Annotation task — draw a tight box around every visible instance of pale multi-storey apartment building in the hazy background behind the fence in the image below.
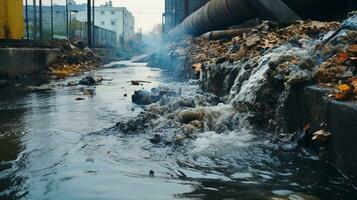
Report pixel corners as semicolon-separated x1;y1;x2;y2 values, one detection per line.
73;1;135;42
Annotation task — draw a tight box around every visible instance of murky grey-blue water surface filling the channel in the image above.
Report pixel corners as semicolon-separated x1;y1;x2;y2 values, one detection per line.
0;62;357;200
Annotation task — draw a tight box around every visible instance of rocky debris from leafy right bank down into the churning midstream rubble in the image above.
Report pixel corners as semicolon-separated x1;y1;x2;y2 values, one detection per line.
119;14;357;153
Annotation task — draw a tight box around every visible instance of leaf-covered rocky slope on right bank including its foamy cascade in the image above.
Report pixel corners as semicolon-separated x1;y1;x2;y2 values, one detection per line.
161;16;357;129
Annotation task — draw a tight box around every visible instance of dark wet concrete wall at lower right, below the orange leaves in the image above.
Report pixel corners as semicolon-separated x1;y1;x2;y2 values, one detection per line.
282;86;357;183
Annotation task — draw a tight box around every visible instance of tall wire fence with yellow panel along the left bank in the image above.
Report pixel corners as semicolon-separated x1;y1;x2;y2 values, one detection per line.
0;0;116;47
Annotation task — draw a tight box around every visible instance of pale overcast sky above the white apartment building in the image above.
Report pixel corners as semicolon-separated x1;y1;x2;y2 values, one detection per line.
48;0;165;32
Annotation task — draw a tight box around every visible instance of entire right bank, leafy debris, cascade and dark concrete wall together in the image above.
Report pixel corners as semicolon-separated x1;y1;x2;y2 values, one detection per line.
149;15;357;183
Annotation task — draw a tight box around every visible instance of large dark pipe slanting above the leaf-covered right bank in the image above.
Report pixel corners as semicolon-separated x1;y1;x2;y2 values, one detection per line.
169;0;348;38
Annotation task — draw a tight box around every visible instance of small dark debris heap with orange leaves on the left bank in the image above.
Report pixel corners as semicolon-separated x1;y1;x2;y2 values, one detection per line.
48;40;104;78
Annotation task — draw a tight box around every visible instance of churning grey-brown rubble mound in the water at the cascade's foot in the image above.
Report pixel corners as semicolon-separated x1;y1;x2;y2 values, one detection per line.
116;85;236;145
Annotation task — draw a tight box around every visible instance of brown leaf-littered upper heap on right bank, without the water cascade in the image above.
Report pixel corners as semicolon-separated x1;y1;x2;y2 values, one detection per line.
170;15;357;100
